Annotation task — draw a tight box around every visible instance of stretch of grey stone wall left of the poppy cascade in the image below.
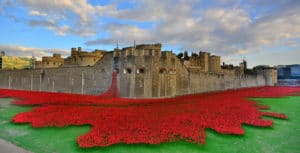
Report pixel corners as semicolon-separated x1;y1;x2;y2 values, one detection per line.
0;54;112;94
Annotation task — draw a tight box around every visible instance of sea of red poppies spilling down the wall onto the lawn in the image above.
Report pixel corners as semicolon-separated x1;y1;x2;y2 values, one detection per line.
0;74;300;148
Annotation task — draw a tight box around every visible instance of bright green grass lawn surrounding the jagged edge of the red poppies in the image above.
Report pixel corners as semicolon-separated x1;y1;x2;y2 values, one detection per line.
0;96;300;153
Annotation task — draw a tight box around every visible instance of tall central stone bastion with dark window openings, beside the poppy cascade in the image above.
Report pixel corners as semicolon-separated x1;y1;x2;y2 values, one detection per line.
119;52;187;97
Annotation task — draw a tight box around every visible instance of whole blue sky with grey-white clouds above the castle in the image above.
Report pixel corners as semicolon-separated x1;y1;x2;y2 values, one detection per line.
0;0;300;66
